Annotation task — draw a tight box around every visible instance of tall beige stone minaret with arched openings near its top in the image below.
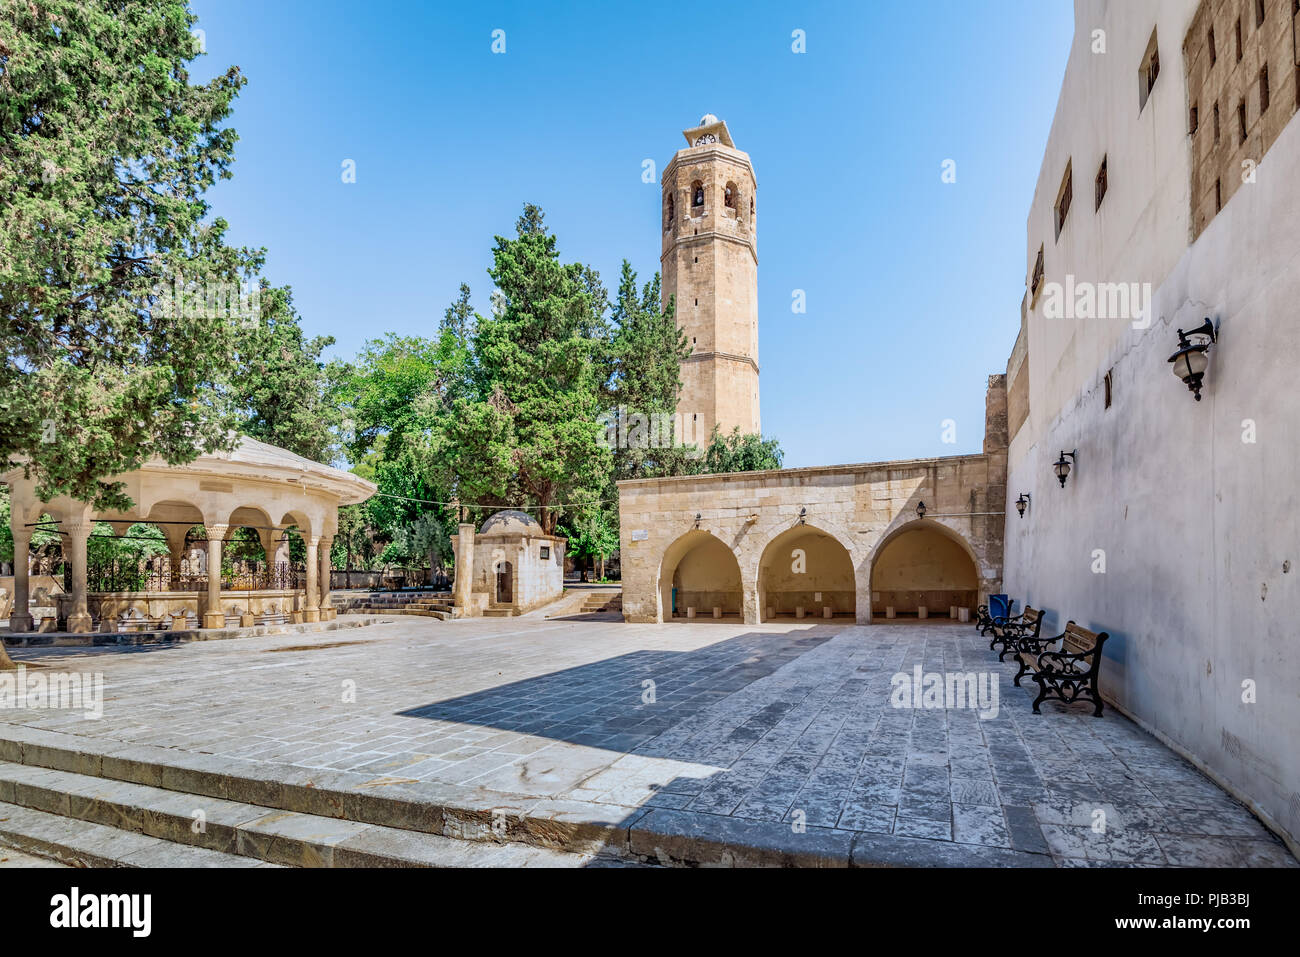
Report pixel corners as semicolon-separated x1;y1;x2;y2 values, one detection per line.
659;114;759;443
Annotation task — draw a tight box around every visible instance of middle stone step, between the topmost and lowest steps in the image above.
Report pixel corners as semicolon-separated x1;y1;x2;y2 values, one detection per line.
0;762;590;867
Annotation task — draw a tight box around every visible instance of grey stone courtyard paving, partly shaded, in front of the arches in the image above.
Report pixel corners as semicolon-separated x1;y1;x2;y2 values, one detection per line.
0;618;1296;866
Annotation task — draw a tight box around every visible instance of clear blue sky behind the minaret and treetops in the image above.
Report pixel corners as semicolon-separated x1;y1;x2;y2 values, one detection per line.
192;0;1074;467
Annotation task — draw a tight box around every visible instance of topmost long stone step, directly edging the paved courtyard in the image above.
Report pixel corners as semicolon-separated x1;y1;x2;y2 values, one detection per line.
0;724;1052;867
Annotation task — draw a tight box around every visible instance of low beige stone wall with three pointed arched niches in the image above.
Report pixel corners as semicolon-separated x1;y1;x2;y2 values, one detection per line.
619;376;1006;623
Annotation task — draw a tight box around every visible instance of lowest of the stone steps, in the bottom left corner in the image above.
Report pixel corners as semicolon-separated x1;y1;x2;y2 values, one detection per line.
0;802;277;867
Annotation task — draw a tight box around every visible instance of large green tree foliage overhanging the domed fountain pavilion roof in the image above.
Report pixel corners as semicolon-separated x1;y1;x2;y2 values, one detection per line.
0;0;261;507
